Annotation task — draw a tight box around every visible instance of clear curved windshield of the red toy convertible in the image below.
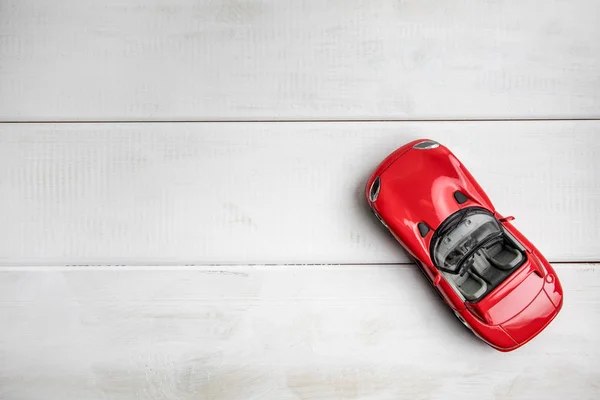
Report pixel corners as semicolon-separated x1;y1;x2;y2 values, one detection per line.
433;209;502;273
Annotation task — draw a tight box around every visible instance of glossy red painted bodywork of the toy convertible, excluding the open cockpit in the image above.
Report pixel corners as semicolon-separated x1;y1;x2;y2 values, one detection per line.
365;139;563;351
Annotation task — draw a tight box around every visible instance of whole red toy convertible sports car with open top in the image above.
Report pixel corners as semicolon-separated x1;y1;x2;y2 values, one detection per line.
365;139;563;351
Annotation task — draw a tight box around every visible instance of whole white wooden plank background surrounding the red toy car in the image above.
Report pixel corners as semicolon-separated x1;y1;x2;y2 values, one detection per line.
0;0;600;400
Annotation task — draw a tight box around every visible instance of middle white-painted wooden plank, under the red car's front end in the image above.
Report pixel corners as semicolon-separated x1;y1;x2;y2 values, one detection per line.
0;121;600;265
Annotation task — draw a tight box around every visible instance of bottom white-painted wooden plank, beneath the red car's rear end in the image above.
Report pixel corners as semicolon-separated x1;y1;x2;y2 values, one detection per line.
0;265;600;400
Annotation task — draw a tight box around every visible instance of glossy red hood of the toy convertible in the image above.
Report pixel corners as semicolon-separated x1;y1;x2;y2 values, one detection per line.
377;146;493;229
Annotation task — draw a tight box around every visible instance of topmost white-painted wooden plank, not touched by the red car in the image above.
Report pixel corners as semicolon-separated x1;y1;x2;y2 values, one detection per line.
0;0;600;121
